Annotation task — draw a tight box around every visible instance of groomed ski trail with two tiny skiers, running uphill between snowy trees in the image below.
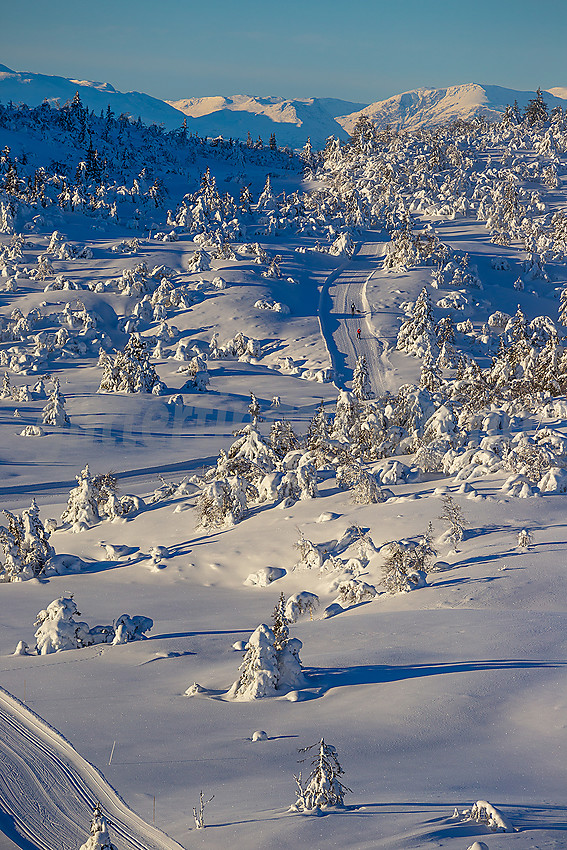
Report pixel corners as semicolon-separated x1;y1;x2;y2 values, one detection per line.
319;237;391;395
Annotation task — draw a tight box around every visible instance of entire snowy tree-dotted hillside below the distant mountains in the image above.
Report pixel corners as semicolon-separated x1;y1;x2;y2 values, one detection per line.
0;69;567;850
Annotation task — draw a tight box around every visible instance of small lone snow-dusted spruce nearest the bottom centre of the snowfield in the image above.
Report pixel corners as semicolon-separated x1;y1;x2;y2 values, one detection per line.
291;738;352;812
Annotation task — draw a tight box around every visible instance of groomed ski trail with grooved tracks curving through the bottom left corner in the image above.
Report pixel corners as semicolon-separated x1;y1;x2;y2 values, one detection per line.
0;688;182;850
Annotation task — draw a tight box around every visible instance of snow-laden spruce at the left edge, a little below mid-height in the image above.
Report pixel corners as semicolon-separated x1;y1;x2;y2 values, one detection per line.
0;499;55;581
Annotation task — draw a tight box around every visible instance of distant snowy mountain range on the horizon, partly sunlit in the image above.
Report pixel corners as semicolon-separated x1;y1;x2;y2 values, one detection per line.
0;65;567;148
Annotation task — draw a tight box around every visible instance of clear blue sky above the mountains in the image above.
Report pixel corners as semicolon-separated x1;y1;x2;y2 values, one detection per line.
0;0;567;102
